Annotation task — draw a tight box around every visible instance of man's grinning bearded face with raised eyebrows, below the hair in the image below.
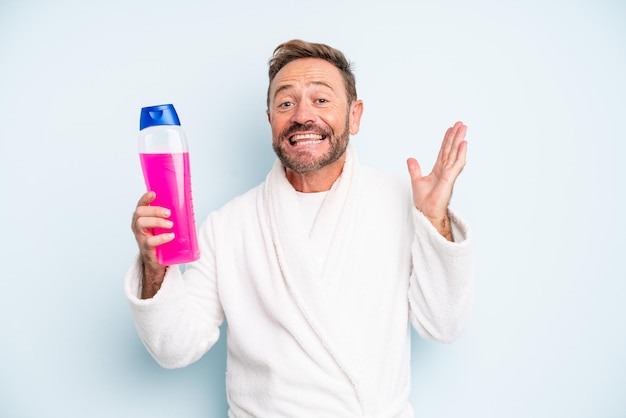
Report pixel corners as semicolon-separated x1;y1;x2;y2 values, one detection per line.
267;58;362;174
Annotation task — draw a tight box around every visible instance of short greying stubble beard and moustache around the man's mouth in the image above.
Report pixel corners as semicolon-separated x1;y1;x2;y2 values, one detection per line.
272;118;350;174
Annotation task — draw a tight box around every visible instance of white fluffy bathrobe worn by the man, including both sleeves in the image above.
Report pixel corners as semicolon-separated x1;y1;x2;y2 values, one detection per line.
125;147;473;418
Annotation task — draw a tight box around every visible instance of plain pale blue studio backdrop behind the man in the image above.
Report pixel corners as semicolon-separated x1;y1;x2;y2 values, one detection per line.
0;0;626;418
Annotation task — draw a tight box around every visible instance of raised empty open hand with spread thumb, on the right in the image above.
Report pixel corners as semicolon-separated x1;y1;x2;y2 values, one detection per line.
407;122;467;241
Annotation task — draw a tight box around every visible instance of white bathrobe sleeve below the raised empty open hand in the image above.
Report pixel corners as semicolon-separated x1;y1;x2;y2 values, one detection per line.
409;208;474;343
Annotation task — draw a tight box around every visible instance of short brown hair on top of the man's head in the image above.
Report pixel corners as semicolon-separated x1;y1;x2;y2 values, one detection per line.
267;39;357;108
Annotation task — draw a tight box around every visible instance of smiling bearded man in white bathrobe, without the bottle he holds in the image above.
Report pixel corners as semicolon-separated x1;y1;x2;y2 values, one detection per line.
126;40;473;417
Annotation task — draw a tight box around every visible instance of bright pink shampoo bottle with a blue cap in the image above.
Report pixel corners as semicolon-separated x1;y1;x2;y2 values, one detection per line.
139;104;200;266
